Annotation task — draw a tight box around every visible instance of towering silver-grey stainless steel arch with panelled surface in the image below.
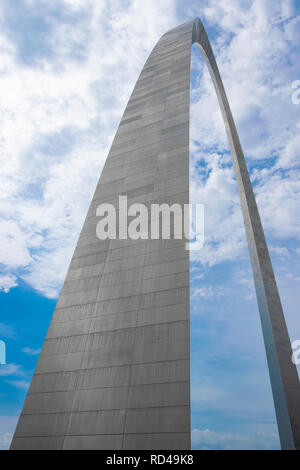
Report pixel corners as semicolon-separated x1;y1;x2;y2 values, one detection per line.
11;19;300;450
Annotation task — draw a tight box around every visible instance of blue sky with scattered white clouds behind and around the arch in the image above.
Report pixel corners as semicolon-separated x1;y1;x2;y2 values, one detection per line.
0;0;300;449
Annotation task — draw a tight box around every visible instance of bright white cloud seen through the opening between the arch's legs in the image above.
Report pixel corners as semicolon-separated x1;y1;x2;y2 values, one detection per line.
191;153;246;265
